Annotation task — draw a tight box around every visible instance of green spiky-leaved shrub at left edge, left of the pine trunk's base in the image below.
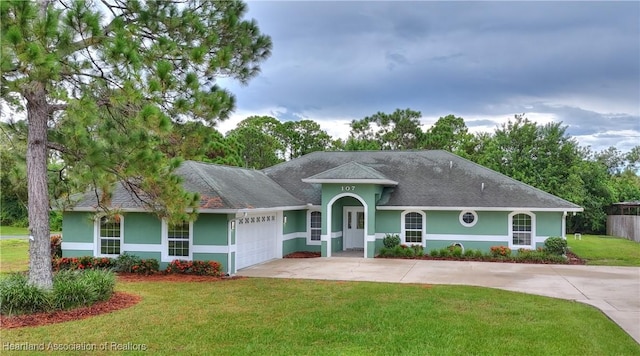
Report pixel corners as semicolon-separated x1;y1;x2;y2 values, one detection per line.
0;273;51;315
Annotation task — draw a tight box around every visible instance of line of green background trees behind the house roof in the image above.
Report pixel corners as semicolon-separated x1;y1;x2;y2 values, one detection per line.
0;109;640;233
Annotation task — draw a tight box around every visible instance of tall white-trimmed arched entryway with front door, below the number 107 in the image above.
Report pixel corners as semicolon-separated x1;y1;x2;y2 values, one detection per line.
326;193;369;257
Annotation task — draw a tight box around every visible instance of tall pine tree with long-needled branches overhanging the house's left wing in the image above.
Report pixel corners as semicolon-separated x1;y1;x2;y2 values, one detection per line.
0;0;271;288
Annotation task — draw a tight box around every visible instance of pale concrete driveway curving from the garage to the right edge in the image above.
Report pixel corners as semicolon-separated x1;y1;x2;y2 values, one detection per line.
237;257;640;343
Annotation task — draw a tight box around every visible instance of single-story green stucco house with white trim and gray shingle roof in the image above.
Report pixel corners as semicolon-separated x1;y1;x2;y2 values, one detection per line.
62;151;583;274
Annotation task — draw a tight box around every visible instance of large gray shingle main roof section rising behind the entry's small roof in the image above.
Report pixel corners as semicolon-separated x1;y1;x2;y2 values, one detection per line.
263;151;581;211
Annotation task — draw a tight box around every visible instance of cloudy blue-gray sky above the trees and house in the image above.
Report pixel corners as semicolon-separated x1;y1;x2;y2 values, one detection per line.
218;1;640;151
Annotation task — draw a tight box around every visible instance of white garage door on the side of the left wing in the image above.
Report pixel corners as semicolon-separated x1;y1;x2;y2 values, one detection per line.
236;213;278;269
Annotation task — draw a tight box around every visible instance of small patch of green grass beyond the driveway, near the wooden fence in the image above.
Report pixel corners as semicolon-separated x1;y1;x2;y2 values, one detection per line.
567;235;640;266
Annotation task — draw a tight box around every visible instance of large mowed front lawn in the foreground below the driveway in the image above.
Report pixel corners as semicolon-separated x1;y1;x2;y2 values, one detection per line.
2;278;640;355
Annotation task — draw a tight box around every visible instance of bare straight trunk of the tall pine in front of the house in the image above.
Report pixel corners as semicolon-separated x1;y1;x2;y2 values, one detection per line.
24;82;53;289
